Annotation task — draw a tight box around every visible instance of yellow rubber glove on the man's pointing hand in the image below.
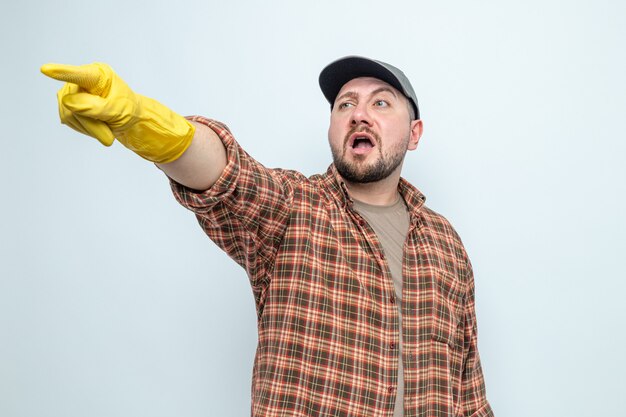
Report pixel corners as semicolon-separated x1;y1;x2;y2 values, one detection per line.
41;63;195;163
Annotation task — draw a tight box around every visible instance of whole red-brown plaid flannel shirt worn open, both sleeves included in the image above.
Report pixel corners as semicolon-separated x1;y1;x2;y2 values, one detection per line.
172;116;493;417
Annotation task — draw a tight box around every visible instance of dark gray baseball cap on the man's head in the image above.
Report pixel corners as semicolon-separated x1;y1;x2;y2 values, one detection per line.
319;56;420;119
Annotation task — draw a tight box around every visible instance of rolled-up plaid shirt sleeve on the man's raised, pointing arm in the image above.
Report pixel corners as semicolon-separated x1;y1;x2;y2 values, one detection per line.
170;116;293;295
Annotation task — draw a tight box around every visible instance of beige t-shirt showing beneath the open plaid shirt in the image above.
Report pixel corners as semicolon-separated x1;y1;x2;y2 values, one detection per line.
354;194;409;417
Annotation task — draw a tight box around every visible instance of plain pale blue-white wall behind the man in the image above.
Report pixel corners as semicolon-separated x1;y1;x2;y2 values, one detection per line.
0;0;626;417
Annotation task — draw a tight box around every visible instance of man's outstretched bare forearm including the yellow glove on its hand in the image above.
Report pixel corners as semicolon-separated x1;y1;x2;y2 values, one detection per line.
41;63;226;190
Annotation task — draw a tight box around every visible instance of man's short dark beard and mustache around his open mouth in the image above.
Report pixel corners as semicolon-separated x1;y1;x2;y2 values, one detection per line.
330;127;409;184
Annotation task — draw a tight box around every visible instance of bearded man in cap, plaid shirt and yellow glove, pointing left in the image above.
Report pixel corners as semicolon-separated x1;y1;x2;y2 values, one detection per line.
42;57;493;417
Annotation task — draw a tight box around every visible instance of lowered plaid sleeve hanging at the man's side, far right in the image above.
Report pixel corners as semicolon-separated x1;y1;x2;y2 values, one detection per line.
461;265;494;417
